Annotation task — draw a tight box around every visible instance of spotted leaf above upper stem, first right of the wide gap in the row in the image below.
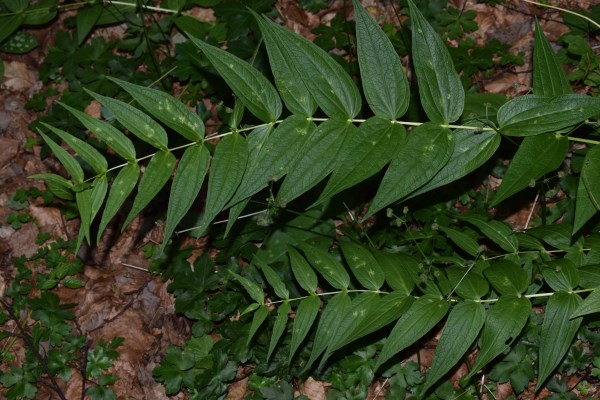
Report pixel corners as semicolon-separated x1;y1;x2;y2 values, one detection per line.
189;35;281;122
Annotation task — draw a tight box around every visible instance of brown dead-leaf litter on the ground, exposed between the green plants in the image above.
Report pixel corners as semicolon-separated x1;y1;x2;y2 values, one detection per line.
0;0;600;399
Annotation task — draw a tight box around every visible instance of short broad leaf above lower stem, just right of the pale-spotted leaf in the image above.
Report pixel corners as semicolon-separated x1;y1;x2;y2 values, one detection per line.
375;251;419;296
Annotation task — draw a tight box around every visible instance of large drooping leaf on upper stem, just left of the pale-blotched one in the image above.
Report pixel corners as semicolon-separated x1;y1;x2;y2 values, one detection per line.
315;117;406;204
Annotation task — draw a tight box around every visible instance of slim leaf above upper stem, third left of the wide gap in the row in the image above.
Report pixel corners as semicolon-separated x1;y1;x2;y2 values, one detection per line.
58;101;135;162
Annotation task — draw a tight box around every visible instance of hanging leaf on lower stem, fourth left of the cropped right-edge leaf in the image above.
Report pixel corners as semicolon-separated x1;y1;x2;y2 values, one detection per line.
374;295;449;370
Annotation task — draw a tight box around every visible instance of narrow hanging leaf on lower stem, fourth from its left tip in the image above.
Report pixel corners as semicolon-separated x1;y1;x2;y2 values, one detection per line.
304;292;350;370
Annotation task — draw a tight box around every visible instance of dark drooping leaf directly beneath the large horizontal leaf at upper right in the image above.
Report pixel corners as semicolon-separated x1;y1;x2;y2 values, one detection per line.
490;134;569;207
